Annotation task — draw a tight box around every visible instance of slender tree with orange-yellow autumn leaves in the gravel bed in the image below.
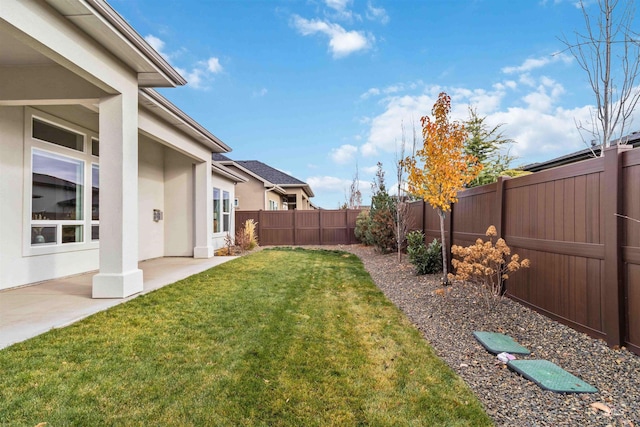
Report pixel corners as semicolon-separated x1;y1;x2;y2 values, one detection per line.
401;92;482;283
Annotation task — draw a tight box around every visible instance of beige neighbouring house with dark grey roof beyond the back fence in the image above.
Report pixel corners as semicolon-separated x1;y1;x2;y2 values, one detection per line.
213;153;316;211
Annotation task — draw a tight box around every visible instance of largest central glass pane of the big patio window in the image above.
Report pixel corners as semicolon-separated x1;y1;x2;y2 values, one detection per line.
31;150;84;220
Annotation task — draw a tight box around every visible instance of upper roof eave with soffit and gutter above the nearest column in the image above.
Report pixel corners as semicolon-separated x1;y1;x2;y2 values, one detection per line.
46;0;187;87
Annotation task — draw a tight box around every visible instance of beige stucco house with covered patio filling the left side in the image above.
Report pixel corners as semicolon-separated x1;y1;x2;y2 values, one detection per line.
0;0;235;298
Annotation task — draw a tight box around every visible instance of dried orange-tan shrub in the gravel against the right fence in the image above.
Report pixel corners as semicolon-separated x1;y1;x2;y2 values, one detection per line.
449;225;530;309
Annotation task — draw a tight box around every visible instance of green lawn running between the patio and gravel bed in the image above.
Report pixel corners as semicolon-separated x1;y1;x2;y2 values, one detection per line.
0;249;491;426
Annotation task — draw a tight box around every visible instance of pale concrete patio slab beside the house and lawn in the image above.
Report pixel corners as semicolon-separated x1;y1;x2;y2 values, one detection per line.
0;256;236;349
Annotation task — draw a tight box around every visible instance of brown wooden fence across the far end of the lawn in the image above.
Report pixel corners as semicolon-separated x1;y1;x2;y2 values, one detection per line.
236;209;360;246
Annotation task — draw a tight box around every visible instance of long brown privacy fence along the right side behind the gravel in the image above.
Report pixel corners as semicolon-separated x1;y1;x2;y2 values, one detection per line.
410;146;640;354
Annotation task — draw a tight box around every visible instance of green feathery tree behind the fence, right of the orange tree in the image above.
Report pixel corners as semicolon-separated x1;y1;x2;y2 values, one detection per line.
464;107;514;187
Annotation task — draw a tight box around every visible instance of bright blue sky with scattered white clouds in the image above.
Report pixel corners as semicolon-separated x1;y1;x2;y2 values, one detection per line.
110;0;640;209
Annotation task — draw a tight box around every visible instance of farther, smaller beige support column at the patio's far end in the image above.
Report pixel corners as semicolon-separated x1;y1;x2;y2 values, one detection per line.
193;159;215;258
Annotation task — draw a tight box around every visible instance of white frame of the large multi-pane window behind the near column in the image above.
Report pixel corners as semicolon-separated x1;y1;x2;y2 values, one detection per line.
22;107;99;256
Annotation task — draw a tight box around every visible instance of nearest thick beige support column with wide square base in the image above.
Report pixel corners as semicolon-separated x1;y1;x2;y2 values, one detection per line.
93;92;143;298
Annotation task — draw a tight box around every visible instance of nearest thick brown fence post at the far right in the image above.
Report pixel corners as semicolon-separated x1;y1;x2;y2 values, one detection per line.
601;145;632;347
